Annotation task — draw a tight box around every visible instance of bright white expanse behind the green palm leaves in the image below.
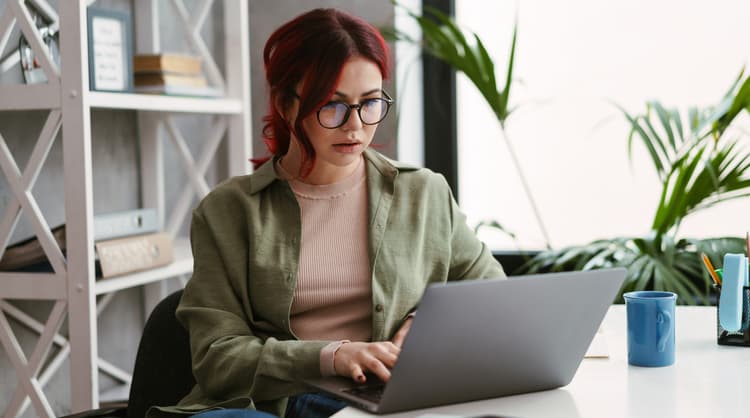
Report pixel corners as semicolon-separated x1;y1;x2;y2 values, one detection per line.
456;0;750;249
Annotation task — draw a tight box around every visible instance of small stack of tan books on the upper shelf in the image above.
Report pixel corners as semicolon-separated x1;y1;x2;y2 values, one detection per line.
133;54;219;97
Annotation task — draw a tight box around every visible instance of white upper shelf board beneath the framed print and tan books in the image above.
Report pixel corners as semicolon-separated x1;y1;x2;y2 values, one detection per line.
88;91;243;114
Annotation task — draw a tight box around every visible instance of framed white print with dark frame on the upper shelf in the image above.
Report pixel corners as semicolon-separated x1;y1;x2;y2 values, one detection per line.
87;7;133;92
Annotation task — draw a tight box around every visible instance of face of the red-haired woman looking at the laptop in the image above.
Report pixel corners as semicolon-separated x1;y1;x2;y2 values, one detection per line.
294;57;383;184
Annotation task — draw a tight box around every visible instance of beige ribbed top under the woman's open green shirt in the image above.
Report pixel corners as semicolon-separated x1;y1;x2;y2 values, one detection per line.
276;159;372;341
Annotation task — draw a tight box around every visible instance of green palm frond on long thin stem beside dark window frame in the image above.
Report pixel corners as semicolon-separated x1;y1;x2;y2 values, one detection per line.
383;1;550;248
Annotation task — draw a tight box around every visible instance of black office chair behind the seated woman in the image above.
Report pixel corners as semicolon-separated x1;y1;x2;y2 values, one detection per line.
66;290;195;418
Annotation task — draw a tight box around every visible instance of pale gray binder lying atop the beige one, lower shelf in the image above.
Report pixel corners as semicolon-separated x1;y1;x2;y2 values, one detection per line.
94;208;159;241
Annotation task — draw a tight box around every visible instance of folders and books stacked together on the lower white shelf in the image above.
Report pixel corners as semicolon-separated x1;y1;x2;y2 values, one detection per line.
0;208;174;278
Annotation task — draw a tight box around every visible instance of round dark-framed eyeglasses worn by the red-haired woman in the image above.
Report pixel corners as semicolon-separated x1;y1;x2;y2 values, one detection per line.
295;91;393;129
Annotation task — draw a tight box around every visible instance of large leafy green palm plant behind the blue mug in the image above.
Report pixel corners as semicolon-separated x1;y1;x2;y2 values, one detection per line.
526;72;750;304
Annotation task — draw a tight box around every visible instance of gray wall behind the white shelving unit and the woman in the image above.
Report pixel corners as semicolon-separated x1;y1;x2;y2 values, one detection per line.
0;0;396;417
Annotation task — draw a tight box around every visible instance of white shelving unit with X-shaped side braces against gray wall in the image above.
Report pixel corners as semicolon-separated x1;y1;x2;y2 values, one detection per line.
0;0;251;418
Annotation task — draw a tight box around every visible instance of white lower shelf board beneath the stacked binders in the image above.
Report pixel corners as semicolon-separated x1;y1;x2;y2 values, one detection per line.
94;238;193;295
